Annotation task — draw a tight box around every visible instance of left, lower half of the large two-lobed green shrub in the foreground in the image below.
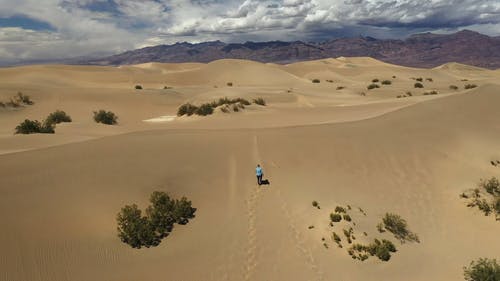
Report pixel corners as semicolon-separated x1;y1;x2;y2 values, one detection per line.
116;204;160;249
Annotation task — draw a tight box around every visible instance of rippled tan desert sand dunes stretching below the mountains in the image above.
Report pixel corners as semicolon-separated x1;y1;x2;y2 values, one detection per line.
0;58;500;281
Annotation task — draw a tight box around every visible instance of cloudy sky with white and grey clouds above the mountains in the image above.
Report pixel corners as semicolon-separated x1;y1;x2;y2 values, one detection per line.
0;0;500;64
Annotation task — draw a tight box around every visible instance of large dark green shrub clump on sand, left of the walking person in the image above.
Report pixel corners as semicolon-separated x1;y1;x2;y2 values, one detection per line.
116;191;196;248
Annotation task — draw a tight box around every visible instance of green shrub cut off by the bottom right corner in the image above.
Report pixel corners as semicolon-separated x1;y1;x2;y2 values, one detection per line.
464;258;500;281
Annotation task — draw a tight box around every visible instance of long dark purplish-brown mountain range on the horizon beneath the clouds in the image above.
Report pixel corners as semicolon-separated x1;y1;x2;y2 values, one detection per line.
78;30;500;69
